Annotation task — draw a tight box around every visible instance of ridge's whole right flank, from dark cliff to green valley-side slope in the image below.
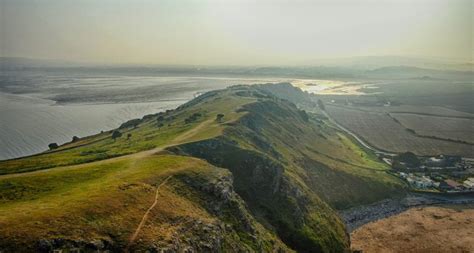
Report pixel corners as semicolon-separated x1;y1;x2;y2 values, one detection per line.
171;86;402;252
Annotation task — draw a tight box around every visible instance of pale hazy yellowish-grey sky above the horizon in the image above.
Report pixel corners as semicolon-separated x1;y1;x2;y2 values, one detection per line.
0;0;473;65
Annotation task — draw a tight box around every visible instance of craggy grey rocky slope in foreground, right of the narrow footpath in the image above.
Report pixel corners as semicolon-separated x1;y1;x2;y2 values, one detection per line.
125;171;292;252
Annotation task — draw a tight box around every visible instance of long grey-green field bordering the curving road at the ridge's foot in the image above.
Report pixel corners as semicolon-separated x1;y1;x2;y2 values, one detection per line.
326;105;474;157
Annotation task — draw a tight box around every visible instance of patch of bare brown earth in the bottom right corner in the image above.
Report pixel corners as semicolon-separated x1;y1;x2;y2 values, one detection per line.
351;205;474;253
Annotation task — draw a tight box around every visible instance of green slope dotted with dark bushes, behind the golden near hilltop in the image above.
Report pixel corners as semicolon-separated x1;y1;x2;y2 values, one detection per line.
0;94;253;175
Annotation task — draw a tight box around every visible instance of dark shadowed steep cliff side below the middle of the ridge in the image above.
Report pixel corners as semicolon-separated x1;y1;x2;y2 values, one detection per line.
169;137;348;252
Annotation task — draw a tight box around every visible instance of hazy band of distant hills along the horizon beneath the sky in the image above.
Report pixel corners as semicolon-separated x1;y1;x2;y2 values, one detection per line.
0;57;474;80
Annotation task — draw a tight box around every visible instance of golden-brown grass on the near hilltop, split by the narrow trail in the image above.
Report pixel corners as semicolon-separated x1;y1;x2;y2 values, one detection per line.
0;155;220;250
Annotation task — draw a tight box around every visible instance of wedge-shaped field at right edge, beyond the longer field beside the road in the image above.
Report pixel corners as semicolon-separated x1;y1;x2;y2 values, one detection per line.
390;113;474;144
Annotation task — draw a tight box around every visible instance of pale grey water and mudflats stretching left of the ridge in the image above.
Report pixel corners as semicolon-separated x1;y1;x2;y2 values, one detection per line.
0;70;322;160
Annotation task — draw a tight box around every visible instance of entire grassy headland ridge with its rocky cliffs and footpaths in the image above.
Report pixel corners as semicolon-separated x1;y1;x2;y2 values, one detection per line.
0;84;404;252
